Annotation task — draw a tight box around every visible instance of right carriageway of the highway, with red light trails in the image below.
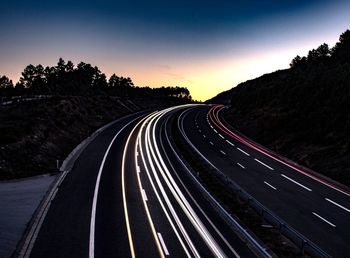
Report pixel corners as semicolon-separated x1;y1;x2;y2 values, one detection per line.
181;106;350;257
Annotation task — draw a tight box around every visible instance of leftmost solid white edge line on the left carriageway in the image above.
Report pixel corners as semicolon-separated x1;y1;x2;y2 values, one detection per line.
89;116;141;258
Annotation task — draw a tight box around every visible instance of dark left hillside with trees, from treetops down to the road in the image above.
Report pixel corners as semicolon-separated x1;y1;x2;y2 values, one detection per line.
0;59;191;179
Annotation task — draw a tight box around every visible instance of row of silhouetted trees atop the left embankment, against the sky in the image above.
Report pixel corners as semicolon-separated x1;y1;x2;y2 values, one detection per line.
0;58;191;100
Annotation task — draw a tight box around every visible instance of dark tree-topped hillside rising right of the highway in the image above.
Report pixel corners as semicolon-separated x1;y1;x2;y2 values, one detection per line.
211;30;350;186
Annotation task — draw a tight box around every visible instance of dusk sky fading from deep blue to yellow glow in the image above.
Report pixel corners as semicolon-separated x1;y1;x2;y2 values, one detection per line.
0;0;350;100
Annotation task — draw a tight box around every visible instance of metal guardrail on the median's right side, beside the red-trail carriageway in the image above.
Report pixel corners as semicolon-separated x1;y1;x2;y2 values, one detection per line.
181;107;331;258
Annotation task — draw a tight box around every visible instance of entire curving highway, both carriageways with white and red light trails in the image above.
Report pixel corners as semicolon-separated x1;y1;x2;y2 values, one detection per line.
25;105;350;258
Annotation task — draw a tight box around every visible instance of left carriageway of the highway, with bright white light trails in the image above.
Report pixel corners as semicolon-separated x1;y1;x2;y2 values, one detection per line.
26;106;258;258
